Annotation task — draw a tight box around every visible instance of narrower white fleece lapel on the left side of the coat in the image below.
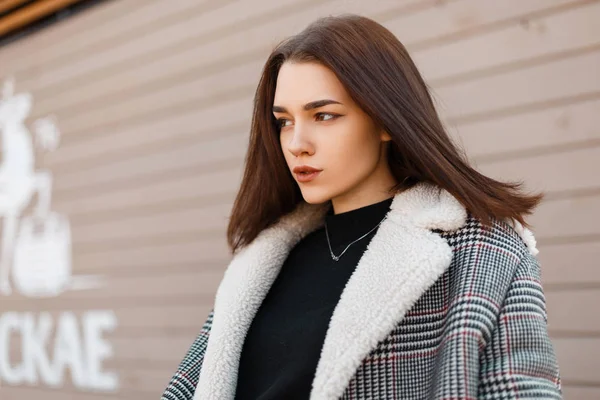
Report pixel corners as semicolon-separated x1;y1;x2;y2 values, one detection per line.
194;203;327;400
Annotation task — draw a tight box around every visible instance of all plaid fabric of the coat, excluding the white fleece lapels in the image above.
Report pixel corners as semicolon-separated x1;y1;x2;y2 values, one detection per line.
162;218;562;400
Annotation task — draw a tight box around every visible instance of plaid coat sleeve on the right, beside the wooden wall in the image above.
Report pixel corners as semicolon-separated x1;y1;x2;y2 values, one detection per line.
478;254;562;399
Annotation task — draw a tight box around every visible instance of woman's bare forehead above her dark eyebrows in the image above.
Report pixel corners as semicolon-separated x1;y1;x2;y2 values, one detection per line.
274;62;348;107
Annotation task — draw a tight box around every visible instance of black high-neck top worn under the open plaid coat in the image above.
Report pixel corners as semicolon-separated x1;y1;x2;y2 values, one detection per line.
235;197;393;400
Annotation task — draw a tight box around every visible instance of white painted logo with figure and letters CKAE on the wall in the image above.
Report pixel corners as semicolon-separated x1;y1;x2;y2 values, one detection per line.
0;80;118;391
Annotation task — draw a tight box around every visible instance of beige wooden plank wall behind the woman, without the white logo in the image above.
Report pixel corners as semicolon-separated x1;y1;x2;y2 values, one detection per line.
0;0;600;400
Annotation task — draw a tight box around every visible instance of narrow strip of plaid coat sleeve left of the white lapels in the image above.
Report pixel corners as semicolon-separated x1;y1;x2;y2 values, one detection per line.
161;310;214;400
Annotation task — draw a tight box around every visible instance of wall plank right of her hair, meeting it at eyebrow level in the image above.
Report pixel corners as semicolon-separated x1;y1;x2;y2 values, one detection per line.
433;47;600;123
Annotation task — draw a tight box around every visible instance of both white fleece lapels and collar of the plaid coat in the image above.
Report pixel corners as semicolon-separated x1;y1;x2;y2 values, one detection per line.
194;184;466;400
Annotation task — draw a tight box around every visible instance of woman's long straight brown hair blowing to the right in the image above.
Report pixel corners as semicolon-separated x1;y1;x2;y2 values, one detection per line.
227;14;542;252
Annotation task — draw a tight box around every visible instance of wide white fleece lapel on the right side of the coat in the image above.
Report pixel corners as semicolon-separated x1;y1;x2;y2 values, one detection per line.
310;185;466;400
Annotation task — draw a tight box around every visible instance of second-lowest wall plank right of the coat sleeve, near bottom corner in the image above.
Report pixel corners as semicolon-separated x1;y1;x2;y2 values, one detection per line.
552;338;600;384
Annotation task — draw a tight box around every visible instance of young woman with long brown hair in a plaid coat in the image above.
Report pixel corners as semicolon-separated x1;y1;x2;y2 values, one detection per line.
163;15;561;400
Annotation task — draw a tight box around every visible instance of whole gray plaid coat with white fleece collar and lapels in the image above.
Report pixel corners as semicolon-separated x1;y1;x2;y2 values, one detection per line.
162;184;562;400
